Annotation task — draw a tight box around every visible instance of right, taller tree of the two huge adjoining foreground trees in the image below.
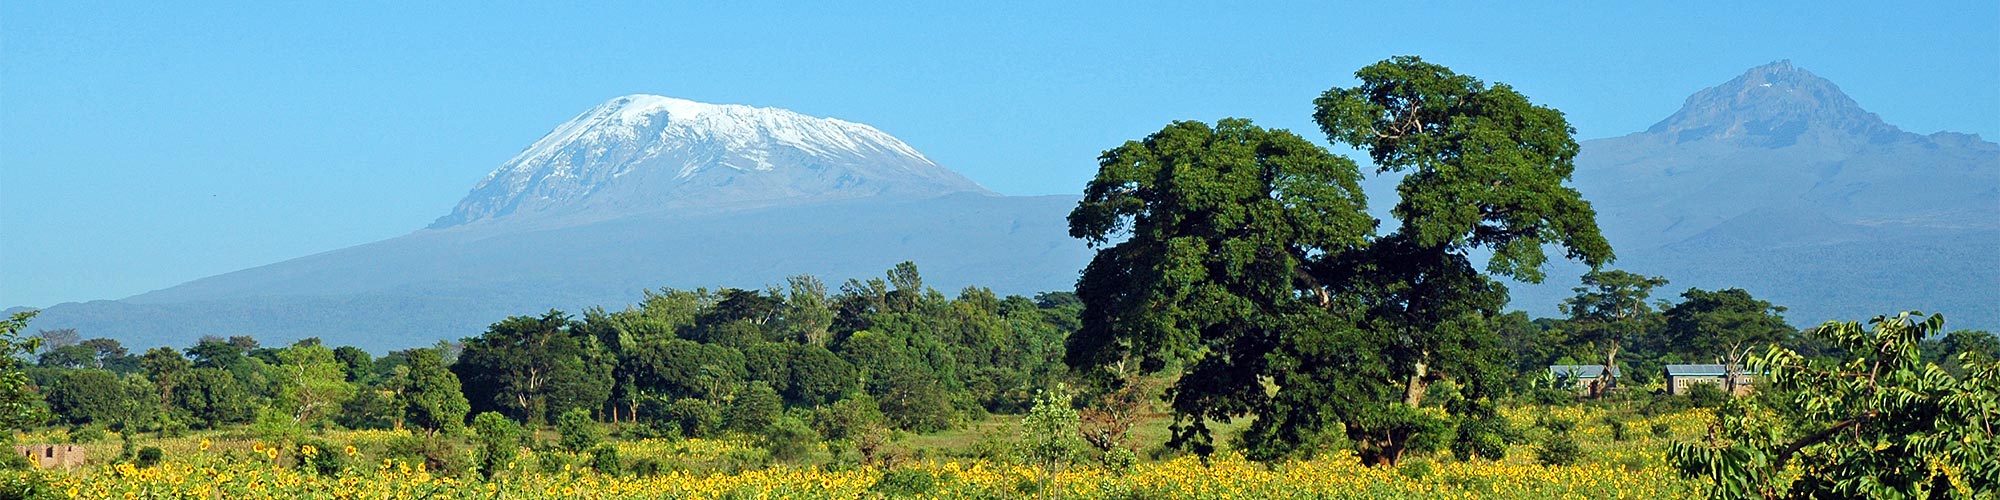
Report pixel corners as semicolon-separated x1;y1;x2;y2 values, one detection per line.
1304;56;1612;464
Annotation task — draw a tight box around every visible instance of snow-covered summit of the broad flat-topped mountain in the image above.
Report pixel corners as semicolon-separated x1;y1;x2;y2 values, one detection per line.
432;94;992;228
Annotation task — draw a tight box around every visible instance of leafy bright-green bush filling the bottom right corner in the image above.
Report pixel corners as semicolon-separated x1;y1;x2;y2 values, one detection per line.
1670;312;2000;498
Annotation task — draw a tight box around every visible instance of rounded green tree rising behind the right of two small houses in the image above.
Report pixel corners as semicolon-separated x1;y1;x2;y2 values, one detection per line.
1664;288;1798;394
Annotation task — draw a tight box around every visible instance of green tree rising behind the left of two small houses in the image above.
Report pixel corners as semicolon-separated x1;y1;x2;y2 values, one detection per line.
1560;270;1664;384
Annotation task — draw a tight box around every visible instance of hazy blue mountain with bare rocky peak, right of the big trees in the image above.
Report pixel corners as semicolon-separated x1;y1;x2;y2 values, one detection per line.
1516;62;2000;328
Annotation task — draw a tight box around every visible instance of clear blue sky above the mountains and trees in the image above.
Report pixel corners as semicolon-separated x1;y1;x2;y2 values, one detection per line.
0;0;2000;306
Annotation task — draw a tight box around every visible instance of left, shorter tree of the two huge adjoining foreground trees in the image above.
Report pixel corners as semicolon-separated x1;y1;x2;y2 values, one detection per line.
1066;120;1374;454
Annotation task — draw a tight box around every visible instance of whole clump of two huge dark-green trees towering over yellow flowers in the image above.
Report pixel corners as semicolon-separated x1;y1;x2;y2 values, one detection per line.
1068;58;1612;464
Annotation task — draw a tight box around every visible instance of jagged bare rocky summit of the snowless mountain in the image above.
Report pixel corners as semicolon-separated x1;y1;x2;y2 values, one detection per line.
1646;60;1908;148
